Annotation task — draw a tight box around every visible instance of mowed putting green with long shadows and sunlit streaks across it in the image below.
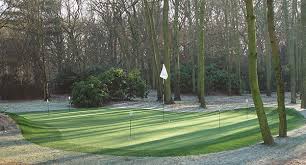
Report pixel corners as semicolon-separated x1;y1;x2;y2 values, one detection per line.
11;108;305;156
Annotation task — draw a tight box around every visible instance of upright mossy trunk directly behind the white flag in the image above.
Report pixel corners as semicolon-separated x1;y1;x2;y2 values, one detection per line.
163;0;173;104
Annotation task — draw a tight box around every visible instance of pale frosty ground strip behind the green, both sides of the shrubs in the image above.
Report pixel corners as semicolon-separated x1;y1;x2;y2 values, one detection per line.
0;92;298;113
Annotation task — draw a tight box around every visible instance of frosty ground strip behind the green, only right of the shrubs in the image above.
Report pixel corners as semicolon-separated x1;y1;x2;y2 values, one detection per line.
109;92;298;112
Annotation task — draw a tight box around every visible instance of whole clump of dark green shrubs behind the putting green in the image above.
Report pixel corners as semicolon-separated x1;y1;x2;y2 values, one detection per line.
72;69;148;107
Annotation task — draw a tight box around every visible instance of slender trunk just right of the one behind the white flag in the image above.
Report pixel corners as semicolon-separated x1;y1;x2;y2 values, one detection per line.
173;0;181;101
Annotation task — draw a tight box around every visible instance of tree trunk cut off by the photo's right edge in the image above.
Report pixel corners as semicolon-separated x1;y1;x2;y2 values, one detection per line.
301;0;306;109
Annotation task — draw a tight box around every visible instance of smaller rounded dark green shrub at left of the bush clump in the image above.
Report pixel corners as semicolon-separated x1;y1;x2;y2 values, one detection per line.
72;76;109;107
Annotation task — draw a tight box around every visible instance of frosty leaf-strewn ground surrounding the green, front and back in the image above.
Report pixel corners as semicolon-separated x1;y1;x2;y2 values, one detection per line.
0;93;306;164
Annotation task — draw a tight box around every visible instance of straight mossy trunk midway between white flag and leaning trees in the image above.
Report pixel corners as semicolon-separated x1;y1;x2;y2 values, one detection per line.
198;0;206;108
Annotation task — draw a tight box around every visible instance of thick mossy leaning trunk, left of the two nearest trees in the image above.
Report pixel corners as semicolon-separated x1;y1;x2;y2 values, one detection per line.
244;0;274;145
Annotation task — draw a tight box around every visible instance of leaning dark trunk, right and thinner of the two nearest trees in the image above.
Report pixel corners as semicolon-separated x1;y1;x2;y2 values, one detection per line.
267;0;287;137
